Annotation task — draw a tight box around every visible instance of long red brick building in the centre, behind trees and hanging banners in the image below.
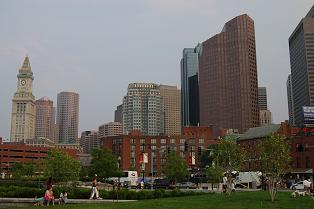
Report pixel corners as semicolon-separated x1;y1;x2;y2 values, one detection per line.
101;127;217;177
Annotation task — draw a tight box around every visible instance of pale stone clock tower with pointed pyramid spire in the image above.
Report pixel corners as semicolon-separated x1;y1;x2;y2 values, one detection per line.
10;56;36;142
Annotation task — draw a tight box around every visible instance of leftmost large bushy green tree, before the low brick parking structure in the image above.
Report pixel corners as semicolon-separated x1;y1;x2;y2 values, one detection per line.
43;149;81;182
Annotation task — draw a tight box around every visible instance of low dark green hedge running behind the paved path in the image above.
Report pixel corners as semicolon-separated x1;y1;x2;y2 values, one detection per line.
0;186;204;200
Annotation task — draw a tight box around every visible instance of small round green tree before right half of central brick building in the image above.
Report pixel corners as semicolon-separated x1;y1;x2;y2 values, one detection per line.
163;152;187;183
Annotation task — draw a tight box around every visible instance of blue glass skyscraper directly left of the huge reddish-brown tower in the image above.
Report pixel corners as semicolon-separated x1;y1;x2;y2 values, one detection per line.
181;44;201;126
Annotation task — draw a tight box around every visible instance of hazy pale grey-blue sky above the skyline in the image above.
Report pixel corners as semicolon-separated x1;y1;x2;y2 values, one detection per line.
0;0;314;139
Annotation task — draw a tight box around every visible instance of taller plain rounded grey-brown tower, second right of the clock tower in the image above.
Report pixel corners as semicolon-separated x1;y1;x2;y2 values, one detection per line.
57;92;79;144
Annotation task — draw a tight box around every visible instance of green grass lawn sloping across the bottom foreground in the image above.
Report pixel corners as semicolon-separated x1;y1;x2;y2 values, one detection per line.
6;192;314;209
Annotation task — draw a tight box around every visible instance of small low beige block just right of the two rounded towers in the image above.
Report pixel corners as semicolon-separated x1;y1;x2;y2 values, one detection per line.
80;131;100;153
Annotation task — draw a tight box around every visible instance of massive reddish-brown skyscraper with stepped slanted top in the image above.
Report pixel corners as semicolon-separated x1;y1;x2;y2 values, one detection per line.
199;14;259;133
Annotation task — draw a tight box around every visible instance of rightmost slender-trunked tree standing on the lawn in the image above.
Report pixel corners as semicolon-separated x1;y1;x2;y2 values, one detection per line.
256;135;291;201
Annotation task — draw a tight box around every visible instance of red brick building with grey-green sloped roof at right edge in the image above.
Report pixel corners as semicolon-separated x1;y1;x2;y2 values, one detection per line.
238;122;314;178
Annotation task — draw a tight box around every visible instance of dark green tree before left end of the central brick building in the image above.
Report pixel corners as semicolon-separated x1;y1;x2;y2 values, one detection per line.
90;148;120;179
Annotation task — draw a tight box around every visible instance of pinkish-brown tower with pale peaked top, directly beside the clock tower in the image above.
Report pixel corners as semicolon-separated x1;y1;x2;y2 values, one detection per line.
35;97;55;141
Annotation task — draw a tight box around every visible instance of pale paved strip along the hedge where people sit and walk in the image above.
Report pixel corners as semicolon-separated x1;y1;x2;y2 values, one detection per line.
0;198;137;204
